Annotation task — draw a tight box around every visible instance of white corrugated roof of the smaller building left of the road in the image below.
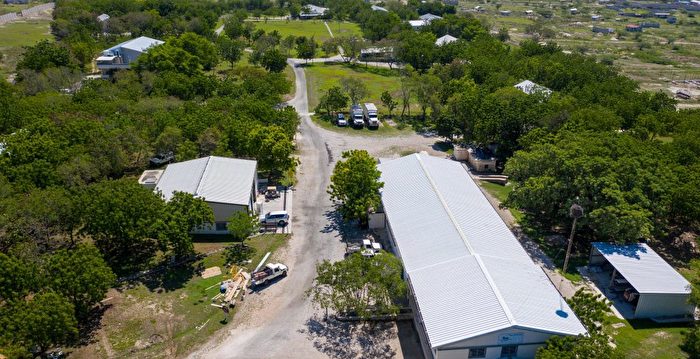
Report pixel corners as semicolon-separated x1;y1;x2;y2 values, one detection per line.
156;156;257;205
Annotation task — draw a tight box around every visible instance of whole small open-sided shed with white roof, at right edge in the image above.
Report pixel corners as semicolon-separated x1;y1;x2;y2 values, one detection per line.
589;242;695;320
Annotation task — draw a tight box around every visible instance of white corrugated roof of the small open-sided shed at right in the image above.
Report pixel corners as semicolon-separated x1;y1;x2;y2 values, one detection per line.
593;242;690;294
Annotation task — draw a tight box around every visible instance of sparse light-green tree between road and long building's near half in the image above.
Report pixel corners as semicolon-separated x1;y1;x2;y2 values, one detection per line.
306;252;406;318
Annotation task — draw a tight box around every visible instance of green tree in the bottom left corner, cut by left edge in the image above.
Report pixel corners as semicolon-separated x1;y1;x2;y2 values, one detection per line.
0;292;78;353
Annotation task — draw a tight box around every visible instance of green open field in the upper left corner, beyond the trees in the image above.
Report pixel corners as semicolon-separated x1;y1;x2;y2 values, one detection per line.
0;20;52;78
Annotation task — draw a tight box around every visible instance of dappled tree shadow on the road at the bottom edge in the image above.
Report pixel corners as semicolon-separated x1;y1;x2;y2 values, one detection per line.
299;317;396;359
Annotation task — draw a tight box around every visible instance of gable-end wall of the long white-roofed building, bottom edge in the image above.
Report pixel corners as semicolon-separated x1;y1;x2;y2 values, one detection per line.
435;328;552;359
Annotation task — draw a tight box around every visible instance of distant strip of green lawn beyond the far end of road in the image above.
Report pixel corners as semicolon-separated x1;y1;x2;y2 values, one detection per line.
254;20;362;42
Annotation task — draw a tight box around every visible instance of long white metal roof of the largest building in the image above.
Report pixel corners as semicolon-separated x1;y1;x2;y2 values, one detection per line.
378;153;586;348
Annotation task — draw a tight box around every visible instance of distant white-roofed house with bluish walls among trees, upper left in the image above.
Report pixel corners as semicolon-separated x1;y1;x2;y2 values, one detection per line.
97;36;164;77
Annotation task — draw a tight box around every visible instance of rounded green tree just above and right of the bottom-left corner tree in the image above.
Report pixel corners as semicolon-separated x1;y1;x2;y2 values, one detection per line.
43;245;116;318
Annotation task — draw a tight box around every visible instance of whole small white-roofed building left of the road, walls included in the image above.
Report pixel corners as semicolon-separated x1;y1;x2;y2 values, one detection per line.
150;156;258;233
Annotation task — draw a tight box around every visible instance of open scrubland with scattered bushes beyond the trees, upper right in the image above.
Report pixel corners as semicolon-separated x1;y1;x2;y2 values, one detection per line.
460;1;700;105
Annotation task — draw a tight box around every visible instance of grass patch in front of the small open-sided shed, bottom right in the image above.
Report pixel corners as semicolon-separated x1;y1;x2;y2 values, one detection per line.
605;317;688;359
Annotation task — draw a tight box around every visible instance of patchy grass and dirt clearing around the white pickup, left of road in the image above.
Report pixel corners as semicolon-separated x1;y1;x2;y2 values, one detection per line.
71;234;288;358
